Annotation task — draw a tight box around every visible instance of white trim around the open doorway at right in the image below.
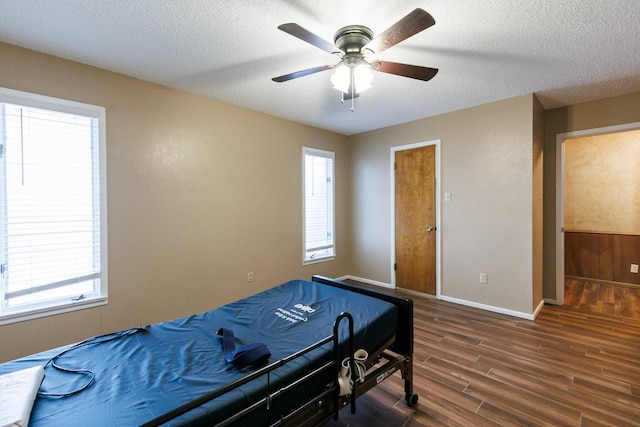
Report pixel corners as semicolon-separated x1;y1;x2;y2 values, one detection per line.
556;122;640;305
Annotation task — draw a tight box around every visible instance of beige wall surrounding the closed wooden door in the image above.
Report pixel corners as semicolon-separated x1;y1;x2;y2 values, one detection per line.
351;95;542;314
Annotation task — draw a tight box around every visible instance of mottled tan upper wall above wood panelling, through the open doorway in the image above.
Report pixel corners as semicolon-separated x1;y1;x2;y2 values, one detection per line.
563;130;640;235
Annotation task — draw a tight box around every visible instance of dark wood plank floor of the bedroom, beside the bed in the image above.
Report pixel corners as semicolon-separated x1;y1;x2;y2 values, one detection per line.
326;282;640;427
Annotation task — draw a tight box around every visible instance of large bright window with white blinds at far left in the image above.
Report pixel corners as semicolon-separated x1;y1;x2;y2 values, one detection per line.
0;89;106;323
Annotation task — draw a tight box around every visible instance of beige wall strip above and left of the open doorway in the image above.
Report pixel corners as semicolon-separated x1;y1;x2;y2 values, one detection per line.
544;93;640;300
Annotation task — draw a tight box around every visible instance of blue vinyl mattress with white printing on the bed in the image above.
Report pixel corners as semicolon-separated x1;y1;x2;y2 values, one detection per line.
0;280;397;427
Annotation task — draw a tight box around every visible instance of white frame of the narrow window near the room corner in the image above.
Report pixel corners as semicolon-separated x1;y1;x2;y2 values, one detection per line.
302;147;337;265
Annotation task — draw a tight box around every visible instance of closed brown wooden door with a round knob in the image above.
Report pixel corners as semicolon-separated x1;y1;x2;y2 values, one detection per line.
394;145;436;295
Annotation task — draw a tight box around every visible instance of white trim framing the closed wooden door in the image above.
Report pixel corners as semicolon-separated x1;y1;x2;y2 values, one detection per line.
389;139;442;299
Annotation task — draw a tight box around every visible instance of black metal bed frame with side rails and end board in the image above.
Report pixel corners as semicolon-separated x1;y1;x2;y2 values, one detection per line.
143;276;418;427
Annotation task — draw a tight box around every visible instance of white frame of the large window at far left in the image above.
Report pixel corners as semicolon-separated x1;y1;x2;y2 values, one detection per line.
0;87;108;325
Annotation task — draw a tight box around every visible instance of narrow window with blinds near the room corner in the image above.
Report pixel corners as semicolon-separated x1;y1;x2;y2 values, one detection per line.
303;147;336;264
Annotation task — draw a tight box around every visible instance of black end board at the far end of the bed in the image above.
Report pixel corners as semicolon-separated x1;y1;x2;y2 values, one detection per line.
311;275;413;356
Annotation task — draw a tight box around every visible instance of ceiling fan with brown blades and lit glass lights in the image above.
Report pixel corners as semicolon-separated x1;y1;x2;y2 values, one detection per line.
272;8;438;111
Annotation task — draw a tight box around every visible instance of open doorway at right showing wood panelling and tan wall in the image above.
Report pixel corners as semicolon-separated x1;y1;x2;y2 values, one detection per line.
554;123;640;314
